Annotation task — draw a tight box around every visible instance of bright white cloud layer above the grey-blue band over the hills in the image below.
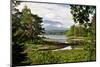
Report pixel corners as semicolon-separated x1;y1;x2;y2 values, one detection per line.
18;2;74;28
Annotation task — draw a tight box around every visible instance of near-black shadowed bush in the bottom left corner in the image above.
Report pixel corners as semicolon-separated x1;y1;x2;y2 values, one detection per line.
12;43;31;66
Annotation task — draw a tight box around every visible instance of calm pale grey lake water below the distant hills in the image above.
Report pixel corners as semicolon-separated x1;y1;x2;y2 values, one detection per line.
44;35;67;43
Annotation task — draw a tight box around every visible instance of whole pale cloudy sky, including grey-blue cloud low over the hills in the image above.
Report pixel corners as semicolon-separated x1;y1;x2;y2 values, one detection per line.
17;2;74;29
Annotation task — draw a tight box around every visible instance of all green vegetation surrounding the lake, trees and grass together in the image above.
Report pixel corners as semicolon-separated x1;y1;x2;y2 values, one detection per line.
12;0;96;66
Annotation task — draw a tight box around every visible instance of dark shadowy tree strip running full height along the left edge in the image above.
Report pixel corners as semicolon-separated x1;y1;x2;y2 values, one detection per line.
11;0;31;66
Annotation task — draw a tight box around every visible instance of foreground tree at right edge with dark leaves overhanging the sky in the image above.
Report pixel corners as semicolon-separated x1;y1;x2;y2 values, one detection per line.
71;5;96;61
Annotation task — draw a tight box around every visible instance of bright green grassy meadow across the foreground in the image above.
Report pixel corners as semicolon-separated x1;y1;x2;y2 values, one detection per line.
22;42;96;64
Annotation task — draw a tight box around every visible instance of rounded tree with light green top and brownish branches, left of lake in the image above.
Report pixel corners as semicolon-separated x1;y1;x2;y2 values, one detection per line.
20;6;44;42
